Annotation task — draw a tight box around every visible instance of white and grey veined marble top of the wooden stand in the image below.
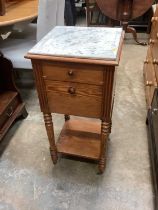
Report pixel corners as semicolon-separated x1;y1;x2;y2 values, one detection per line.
29;26;122;60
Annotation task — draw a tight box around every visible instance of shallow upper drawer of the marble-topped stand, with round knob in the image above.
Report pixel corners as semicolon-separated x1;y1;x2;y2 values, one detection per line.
42;62;104;85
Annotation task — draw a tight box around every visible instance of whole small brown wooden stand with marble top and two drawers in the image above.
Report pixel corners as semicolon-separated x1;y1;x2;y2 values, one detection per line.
27;27;123;173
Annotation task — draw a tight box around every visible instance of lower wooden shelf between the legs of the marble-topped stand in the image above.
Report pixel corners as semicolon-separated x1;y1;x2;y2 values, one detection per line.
57;119;101;160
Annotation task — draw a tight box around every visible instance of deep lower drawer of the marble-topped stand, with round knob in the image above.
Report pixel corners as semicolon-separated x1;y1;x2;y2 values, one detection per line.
45;80;102;117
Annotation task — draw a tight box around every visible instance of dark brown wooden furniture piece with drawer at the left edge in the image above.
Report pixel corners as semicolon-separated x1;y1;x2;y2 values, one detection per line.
0;53;27;140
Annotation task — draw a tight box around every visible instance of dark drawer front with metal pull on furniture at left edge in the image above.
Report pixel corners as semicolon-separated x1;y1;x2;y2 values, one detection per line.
0;96;19;133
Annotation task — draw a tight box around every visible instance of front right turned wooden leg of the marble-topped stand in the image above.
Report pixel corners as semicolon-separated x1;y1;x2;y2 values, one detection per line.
99;121;111;174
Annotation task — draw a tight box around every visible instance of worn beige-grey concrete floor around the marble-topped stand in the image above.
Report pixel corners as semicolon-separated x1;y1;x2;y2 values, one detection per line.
0;32;154;210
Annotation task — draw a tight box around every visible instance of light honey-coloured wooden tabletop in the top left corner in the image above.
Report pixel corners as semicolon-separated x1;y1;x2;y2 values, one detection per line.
0;0;38;27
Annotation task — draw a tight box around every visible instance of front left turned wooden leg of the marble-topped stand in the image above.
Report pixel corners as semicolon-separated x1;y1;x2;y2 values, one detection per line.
43;113;58;164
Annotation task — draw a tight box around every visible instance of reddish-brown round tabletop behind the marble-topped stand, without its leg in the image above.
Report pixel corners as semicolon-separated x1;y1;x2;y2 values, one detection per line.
96;0;153;21
